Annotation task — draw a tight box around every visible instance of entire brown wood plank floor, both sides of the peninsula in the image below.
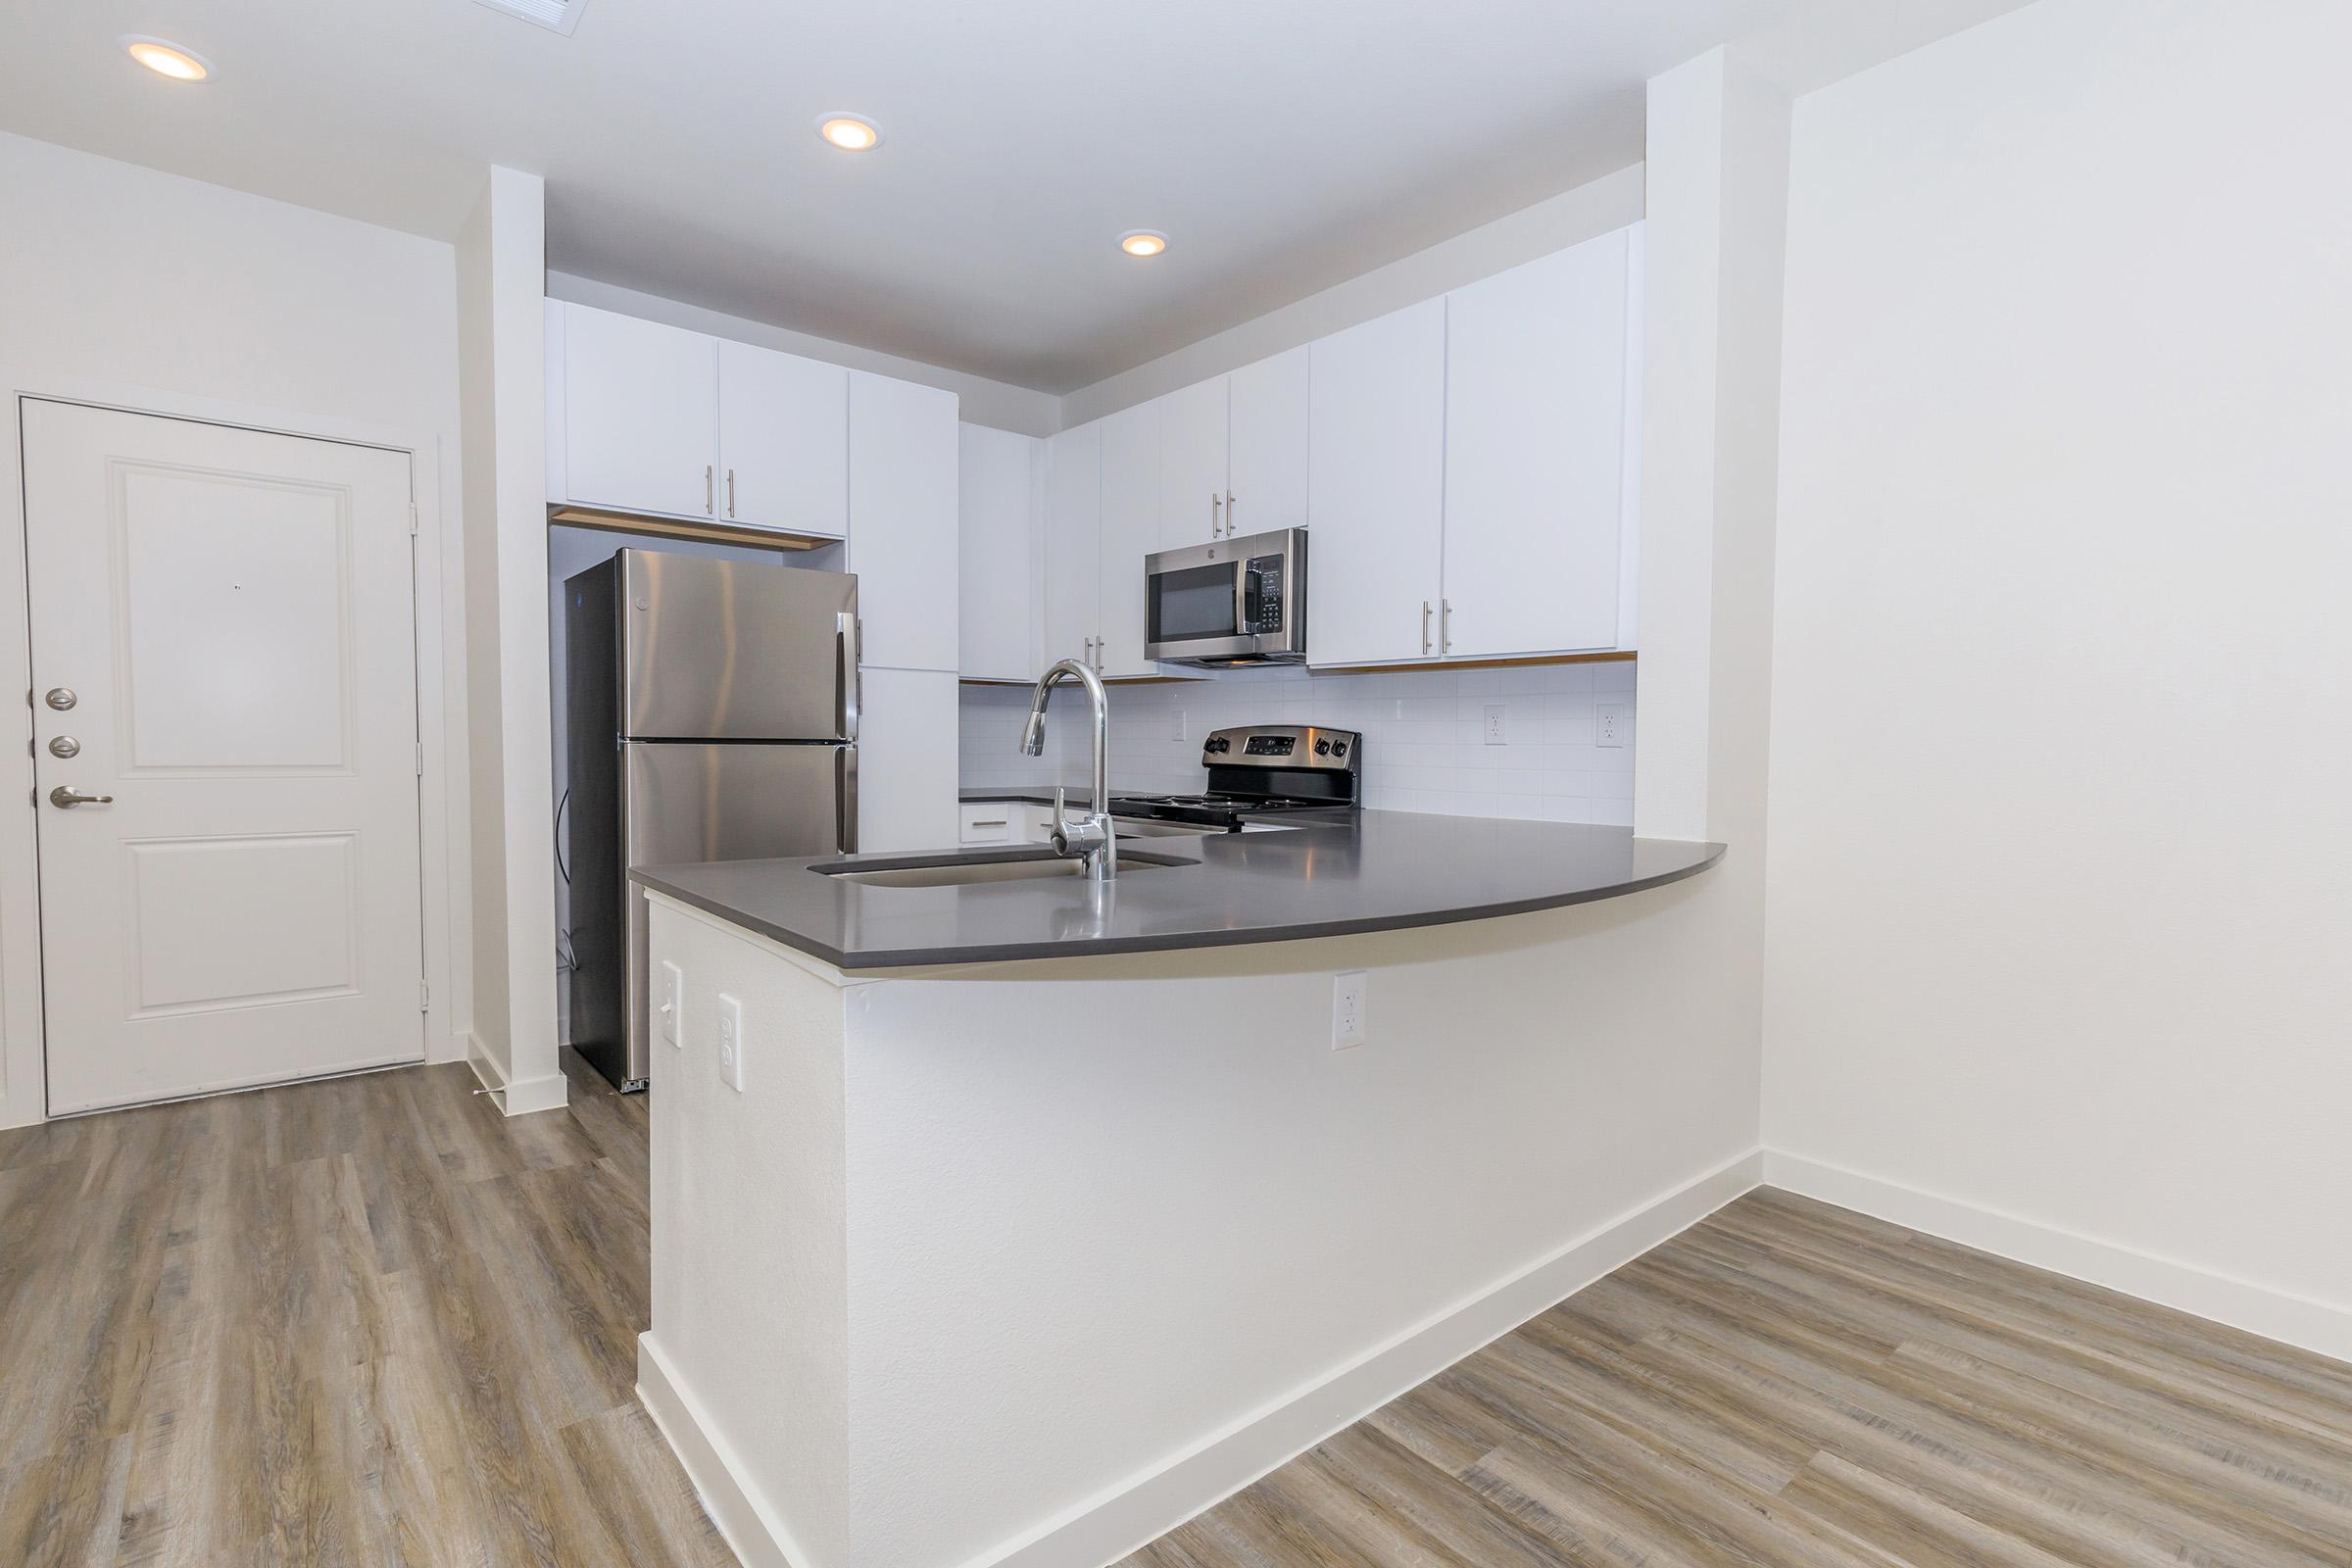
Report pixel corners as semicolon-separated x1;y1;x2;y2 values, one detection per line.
18;1062;2352;1568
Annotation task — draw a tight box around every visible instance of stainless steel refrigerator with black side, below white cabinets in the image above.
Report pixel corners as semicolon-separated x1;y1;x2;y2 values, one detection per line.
564;550;858;1091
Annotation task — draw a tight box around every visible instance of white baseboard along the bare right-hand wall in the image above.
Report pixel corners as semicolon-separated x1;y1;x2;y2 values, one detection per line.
1764;1150;2352;1361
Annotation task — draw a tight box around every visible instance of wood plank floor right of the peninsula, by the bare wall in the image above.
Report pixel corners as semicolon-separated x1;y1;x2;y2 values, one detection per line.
1124;1190;2352;1568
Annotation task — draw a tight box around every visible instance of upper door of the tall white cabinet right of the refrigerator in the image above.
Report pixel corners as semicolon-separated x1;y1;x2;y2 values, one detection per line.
849;371;962;674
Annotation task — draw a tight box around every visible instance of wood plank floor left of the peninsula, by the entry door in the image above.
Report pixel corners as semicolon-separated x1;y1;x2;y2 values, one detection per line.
0;1054;734;1568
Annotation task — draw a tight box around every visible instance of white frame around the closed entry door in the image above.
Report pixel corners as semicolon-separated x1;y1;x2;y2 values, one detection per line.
0;365;472;1128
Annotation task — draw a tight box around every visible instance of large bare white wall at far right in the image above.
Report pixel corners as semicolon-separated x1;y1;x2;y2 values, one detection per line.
1768;0;2352;1354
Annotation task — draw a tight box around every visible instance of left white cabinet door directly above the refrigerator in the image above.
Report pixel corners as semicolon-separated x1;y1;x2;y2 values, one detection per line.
563;306;719;517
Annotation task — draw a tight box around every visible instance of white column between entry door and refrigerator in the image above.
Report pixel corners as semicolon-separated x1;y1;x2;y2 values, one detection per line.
457;167;564;1116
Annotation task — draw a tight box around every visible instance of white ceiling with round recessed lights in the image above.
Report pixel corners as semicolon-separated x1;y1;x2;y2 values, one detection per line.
0;0;1789;393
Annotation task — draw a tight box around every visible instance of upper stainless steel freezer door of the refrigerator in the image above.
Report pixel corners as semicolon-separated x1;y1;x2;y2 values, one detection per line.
616;550;858;747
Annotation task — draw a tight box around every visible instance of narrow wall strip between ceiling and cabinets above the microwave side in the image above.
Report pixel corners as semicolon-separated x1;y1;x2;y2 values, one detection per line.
1058;165;1642;428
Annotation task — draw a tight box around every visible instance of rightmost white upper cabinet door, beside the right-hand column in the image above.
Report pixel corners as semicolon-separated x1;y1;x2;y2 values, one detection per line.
1430;232;1628;659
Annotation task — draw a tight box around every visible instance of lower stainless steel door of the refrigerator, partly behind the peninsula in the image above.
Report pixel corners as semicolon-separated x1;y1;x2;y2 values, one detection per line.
588;741;858;1089
